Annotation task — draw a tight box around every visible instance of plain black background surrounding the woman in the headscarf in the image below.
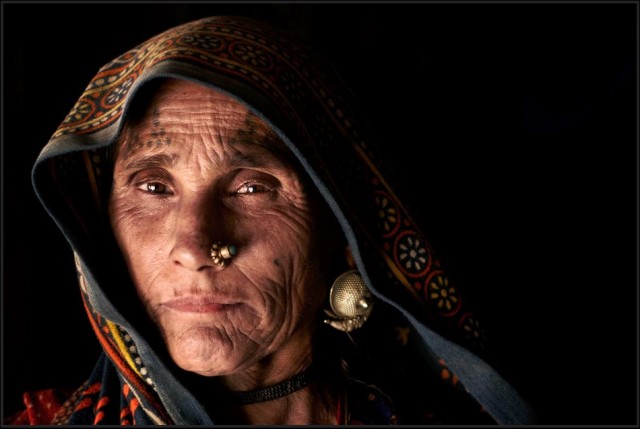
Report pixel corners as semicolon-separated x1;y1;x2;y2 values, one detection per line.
2;2;638;425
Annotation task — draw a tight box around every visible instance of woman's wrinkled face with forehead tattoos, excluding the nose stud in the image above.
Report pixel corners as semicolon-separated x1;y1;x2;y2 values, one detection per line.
109;80;336;376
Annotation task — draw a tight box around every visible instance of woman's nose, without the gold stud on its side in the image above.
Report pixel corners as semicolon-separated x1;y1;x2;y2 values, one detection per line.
170;198;230;271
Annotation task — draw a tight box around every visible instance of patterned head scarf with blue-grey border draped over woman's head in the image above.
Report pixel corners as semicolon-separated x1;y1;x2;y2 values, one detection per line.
21;16;533;424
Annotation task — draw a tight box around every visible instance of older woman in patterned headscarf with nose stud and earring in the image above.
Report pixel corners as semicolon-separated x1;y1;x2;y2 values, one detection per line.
11;17;532;425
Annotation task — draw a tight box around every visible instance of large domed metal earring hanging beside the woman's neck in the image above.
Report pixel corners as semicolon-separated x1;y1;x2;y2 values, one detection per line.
324;270;374;332
